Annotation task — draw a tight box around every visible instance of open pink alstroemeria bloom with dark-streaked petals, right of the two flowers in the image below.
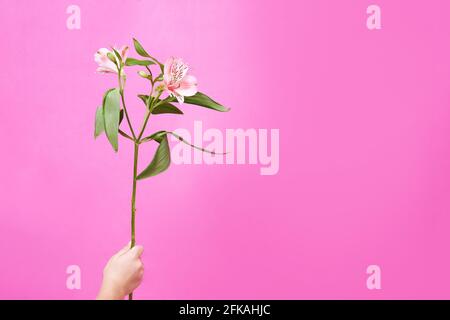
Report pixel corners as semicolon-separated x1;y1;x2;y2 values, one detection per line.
163;57;197;103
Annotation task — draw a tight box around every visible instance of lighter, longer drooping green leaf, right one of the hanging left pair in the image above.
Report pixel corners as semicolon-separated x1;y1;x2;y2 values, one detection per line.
102;88;120;152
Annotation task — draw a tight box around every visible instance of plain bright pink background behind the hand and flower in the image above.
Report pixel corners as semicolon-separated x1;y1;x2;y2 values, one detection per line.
0;0;450;299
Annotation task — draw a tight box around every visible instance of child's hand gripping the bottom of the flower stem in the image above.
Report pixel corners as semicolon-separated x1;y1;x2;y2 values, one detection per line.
97;243;144;300
